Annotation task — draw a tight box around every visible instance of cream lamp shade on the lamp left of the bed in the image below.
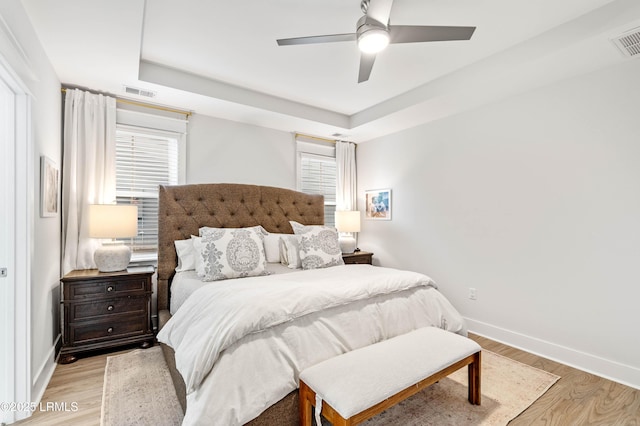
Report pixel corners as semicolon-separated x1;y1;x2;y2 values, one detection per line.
89;204;138;238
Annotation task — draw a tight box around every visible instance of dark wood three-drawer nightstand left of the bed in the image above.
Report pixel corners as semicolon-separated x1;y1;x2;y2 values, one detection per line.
59;267;155;364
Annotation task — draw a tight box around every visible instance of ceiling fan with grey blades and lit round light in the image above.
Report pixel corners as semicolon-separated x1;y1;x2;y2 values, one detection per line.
277;0;476;83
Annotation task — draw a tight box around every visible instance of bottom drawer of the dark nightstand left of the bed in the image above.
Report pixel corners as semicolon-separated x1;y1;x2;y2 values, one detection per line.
69;315;147;345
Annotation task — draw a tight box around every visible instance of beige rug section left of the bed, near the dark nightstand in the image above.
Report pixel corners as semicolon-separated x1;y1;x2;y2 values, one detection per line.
100;346;183;426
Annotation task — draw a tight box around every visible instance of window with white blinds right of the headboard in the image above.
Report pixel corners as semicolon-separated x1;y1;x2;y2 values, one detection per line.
297;140;336;226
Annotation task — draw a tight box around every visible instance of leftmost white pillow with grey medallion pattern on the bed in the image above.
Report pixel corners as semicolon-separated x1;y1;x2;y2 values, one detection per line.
202;228;268;281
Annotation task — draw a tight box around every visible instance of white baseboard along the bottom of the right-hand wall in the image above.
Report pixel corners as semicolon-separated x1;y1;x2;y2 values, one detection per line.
465;318;640;389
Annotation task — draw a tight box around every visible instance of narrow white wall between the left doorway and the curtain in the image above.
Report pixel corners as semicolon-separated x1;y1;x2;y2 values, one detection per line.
0;0;61;410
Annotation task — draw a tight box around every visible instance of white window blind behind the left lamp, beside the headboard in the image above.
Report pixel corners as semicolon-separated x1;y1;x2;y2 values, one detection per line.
116;126;179;261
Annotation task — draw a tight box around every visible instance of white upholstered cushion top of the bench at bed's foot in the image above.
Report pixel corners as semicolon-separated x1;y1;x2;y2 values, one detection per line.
300;327;481;419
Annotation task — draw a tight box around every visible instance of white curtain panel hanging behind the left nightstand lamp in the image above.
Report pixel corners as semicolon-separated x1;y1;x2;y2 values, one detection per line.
62;89;116;274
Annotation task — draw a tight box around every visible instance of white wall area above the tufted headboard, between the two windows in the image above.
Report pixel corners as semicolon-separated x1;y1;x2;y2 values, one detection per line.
187;114;296;189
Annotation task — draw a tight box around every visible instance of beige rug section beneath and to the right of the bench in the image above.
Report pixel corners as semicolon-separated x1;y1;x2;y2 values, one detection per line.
363;349;560;426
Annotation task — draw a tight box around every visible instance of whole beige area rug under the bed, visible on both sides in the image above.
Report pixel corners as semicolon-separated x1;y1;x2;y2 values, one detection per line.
101;347;560;426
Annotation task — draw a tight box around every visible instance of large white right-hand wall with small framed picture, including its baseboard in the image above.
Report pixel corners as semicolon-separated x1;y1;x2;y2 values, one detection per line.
357;60;640;387
